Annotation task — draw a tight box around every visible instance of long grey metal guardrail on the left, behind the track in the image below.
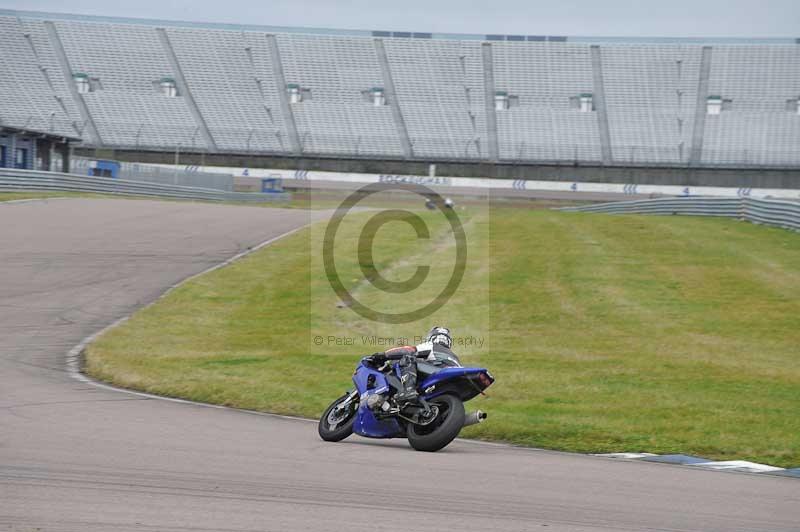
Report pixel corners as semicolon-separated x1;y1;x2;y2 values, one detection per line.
0;168;290;202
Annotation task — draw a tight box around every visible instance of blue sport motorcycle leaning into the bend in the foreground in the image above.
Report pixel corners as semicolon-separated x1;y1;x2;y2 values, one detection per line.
319;344;494;452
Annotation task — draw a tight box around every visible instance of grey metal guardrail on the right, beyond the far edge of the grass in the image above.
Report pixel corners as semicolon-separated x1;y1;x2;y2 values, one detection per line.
559;197;800;231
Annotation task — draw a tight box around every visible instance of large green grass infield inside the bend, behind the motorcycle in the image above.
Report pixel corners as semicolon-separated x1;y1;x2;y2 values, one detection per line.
86;207;800;467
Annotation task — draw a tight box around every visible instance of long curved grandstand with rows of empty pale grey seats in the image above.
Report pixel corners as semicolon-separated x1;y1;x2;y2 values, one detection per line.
0;10;800;168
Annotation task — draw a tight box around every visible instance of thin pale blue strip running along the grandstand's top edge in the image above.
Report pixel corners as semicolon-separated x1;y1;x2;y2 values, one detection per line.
0;9;800;45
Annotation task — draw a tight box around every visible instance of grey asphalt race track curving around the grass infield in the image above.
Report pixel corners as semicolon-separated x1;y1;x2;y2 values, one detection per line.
0;199;800;532
